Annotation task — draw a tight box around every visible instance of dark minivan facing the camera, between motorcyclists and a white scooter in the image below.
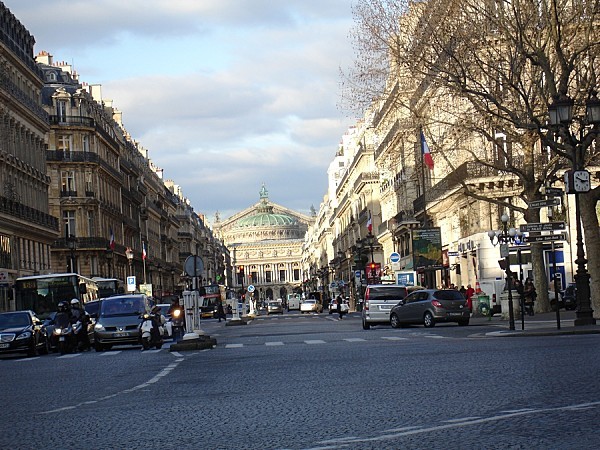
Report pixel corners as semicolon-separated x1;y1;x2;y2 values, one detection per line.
94;294;151;352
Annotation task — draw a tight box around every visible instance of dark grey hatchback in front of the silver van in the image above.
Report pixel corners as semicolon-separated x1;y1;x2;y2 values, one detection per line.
390;289;471;328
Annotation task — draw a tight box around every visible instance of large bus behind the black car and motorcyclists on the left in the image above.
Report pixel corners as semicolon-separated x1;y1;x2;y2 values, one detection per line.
15;273;98;319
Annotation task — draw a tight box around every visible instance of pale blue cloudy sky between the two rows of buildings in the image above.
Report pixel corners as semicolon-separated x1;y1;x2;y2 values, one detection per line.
1;0;356;223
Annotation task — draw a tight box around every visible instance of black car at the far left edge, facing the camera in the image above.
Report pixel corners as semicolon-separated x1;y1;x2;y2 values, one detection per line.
0;311;48;356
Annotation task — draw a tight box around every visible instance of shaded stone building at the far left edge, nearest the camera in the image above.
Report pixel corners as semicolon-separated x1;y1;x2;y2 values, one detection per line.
0;3;58;310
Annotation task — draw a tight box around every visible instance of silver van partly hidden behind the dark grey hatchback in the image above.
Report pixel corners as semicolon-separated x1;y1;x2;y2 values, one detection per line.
361;284;408;330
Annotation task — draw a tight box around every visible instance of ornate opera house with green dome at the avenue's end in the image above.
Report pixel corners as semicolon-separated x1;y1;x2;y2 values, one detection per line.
214;185;314;301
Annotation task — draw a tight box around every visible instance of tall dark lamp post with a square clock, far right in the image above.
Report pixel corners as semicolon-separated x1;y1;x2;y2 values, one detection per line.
548;92;600;326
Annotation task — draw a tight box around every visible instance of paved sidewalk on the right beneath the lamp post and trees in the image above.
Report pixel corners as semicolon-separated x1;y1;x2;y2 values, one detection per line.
469;309;600;337
